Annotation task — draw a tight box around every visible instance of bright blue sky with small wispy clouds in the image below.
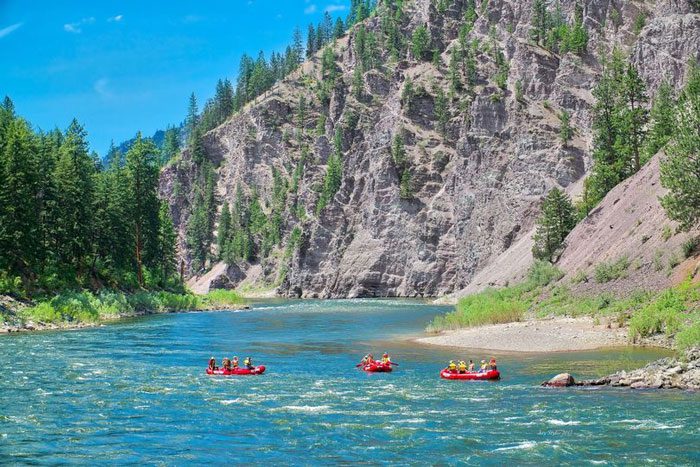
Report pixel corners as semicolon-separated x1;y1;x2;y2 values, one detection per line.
0;0;350;154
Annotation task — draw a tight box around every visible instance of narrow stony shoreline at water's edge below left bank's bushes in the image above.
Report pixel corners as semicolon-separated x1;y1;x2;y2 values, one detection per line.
0;304;250;335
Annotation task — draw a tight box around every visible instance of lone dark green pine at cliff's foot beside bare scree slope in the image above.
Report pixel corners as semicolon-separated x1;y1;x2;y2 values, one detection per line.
532;188;576;262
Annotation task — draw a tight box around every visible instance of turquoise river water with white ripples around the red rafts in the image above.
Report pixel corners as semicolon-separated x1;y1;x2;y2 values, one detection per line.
0;300;700;465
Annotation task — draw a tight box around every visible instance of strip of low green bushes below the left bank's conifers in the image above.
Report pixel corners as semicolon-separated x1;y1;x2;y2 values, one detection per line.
0;290;246;332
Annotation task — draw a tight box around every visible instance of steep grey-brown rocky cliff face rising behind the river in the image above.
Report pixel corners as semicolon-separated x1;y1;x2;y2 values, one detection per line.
161;0;700;297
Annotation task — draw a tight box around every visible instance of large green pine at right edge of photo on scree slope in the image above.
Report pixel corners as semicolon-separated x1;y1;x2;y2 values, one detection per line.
661;63;700;230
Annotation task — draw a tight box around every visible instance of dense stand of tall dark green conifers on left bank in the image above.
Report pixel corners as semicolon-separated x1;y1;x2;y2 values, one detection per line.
0;98;178;296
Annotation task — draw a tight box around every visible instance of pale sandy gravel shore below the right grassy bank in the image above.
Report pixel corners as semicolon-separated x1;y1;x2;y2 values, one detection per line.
416;318;629;352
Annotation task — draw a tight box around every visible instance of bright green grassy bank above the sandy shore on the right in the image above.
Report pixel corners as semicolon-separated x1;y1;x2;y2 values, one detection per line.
427;263;700;349
